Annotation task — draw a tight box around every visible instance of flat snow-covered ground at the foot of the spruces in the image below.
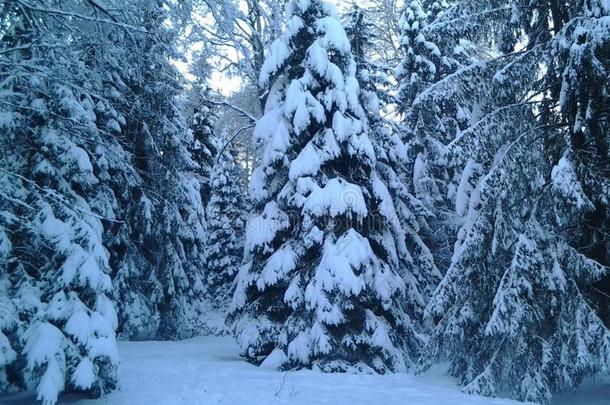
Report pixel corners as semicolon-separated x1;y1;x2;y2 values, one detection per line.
0;337;610;405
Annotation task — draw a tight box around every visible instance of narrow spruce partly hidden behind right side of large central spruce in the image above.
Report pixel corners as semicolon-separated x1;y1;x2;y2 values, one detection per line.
345;6;442;320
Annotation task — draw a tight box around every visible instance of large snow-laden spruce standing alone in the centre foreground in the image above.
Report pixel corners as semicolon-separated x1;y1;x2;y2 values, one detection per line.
229;0;421;372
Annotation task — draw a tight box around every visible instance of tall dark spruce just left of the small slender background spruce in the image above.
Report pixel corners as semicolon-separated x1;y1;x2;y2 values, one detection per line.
113;1;205;339
